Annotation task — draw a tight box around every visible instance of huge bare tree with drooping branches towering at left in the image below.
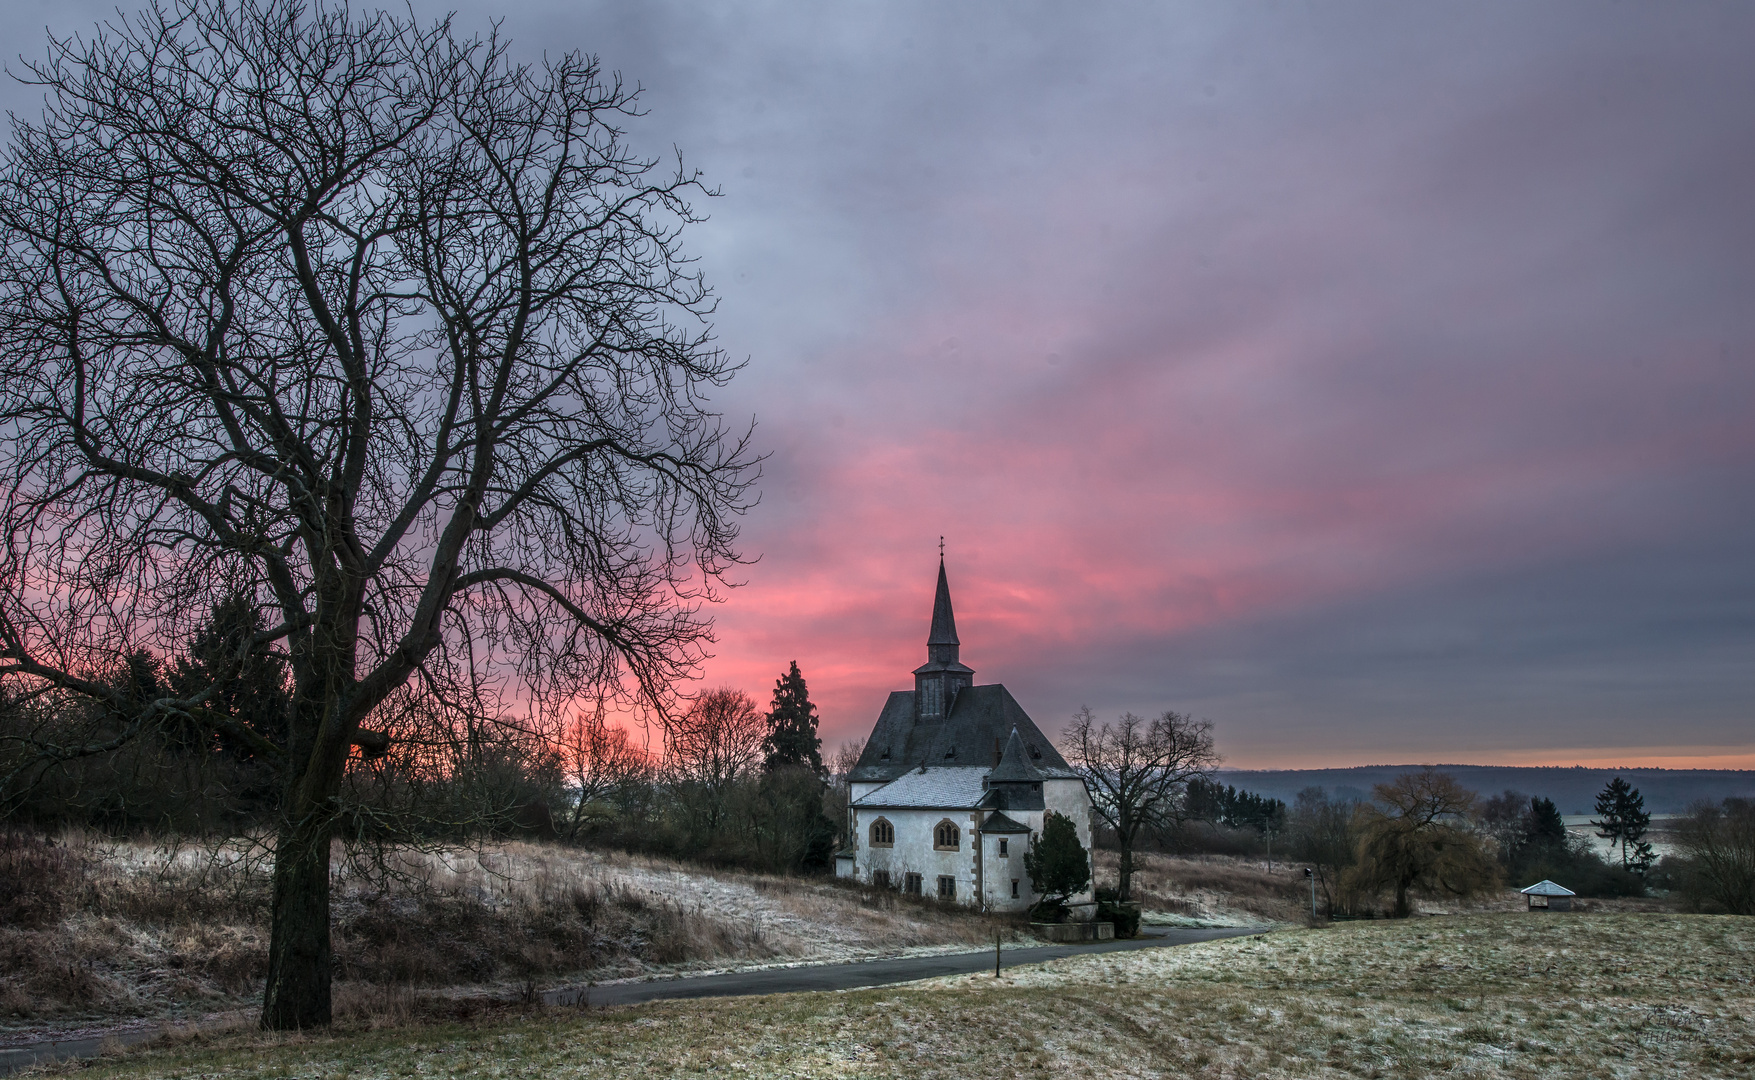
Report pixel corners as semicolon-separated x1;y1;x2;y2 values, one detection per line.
0;0;755;1029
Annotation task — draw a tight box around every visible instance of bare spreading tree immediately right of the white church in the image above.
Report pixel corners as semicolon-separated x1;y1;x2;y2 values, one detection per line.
1060;706;1220;903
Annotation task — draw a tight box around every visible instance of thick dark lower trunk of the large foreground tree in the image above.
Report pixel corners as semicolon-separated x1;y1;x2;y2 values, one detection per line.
261;815;333;1031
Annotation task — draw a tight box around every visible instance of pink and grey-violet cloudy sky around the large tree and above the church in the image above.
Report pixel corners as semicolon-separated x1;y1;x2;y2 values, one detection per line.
0;0;1755;767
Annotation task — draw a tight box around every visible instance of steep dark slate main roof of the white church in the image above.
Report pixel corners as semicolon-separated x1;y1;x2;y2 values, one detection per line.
848;683;1078;783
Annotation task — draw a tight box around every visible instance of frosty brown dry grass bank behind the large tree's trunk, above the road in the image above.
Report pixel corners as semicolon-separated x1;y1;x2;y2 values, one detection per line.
0;834;993;1038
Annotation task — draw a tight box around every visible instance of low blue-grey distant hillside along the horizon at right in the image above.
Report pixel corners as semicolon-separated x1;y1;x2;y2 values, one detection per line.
1220;766;1755;813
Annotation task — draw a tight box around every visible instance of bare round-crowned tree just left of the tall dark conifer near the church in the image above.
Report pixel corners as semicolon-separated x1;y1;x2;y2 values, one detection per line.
665;687;767;834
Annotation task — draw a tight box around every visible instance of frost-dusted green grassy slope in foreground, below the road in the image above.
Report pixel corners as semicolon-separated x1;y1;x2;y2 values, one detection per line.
61;915;1755;1078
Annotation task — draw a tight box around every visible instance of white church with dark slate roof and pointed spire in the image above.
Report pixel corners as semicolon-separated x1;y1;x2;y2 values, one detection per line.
835;557;1092;911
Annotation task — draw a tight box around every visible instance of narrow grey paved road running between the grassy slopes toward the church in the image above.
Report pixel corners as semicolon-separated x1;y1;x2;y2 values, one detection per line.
0;927;1262;1076
